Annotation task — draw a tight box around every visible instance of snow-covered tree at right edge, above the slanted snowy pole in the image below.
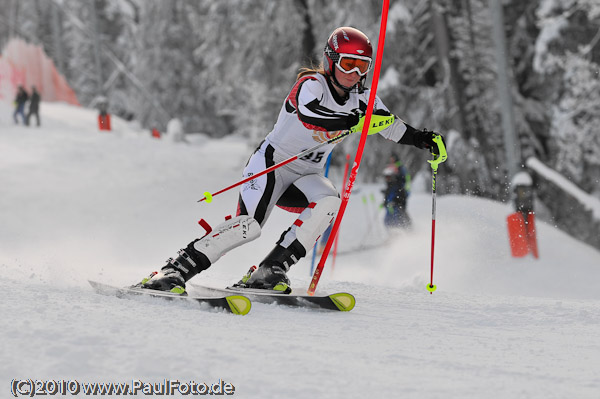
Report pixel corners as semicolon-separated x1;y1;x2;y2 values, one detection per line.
535;0;600;194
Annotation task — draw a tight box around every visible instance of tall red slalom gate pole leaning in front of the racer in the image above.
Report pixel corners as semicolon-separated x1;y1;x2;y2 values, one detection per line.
307;0;390;295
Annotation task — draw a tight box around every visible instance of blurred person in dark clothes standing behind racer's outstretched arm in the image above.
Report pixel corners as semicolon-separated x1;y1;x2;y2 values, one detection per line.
383;155;411;228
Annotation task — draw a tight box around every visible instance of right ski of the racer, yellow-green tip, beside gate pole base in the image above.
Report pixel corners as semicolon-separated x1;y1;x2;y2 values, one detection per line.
193;285;356;312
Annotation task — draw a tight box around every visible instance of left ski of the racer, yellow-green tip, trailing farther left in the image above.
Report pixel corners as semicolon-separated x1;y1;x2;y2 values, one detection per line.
88;280;252;315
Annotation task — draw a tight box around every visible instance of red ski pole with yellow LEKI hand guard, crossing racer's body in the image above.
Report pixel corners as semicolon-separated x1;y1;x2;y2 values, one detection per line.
197;115;394;203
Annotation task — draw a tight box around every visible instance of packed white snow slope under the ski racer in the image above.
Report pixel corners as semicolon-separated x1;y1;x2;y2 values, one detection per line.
0;103;600;399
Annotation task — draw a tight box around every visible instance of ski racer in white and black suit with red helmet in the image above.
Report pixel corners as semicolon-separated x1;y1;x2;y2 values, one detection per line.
140;27;446;294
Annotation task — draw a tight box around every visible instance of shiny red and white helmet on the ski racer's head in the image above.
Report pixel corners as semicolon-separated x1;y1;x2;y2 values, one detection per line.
323;26;373;76
